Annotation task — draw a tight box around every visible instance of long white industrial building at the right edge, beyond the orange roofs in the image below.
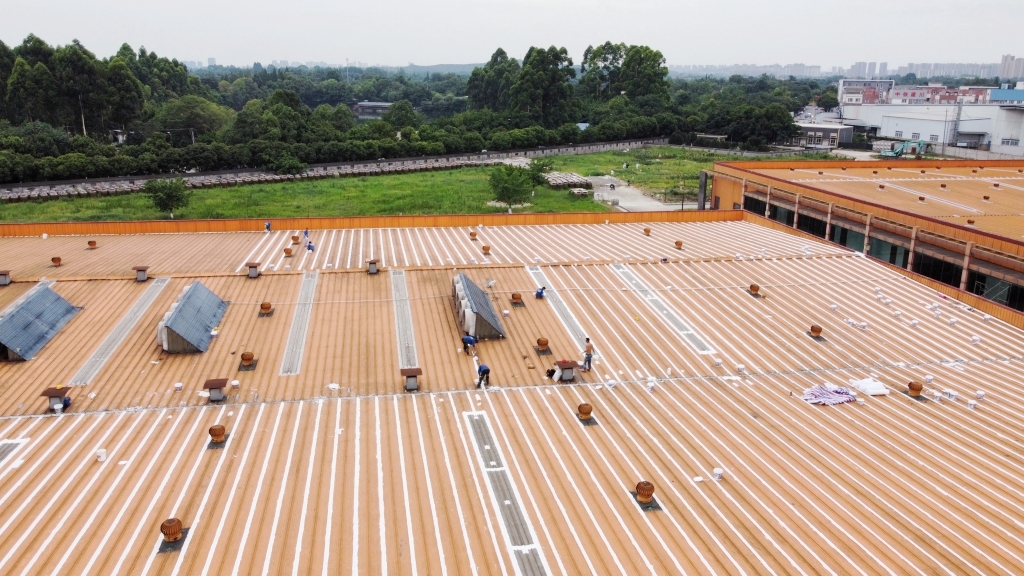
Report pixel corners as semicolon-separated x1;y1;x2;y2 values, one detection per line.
842;104;1024;156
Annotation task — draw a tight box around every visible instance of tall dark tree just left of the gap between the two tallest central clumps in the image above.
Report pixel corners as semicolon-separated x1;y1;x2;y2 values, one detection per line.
509;46;575;128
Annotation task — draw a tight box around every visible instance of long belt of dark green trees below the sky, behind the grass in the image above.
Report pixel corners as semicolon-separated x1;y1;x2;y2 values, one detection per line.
0;35;824;182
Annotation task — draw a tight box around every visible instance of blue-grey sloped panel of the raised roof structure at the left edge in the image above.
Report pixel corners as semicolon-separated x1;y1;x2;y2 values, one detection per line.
0;286;81;360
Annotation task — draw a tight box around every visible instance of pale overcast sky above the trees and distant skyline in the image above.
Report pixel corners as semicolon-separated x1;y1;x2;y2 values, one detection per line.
0;0;1024;70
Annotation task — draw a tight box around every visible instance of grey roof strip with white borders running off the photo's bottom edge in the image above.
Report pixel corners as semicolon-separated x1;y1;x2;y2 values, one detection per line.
463;412;547;576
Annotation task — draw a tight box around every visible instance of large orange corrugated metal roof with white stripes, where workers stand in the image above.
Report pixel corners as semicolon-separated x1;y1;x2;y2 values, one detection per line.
0;213;1024;575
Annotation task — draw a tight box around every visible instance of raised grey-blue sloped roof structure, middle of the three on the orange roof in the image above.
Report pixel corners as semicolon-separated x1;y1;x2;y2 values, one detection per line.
157;282;227;354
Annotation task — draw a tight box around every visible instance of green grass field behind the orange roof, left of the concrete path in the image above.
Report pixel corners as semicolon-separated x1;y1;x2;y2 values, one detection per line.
0;168;607;222
